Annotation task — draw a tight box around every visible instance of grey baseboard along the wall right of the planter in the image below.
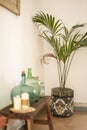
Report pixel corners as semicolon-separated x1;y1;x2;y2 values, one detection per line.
74;102;87;112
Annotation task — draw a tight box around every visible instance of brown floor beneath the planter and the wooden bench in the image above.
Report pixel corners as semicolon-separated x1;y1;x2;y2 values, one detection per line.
34;111;87;130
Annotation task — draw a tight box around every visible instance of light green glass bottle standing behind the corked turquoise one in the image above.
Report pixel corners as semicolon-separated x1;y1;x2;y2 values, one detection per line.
26;68;41;101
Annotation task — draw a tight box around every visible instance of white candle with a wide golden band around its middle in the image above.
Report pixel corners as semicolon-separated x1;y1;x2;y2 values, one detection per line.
21;93;30;110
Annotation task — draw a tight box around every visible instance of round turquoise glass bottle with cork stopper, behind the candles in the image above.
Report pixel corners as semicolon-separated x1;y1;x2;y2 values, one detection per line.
10;71;36;105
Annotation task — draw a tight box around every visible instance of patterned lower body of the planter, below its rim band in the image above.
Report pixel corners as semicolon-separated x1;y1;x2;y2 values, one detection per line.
50;97;74;117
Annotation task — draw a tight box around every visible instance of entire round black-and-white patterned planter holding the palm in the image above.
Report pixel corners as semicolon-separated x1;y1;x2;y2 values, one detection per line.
50;88;74;117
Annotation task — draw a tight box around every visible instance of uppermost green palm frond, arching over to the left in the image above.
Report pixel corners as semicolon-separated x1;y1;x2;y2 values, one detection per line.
32;12;62;35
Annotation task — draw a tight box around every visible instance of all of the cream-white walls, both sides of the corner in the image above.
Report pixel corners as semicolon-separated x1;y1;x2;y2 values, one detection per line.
0;0;87;108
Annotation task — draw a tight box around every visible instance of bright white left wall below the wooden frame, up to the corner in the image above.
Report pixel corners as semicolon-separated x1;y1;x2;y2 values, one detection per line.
0;0;43;109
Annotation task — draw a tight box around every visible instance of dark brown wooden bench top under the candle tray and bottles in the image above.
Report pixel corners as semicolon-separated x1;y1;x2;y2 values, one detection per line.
0;96;50;120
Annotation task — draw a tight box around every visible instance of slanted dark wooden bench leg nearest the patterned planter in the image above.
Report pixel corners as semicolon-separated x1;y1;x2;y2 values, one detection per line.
46;103;53;130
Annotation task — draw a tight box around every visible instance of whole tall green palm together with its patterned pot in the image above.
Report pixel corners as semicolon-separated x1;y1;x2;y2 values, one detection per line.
32;11;87;117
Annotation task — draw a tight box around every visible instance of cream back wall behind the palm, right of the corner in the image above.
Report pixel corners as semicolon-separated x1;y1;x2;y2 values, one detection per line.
42;0;87;103
